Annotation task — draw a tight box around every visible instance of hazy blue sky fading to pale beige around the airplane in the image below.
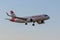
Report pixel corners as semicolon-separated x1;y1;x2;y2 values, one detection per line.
0;0;60;40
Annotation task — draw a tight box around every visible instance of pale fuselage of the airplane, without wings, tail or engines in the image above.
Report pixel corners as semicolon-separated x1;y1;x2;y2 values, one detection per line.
15;15;49;23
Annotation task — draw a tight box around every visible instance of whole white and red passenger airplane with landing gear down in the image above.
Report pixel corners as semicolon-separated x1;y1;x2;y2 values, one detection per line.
6;10;50;26
